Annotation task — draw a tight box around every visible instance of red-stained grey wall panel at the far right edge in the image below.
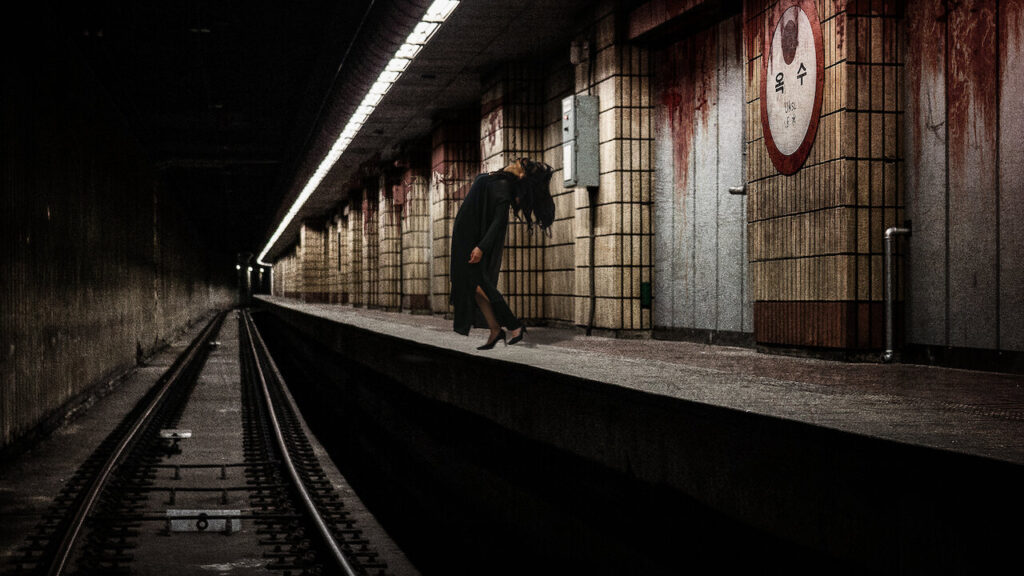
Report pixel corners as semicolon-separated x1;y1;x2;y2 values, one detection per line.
905;0;1024;352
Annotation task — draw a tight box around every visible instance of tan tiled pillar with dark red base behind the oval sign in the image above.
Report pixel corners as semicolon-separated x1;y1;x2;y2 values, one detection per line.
743;1;903;349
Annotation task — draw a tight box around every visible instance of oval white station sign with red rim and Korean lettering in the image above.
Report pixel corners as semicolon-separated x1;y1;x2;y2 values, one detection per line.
761;0;824;174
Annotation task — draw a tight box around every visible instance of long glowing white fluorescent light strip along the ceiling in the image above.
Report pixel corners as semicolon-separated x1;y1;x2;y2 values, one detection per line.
256;0;459;265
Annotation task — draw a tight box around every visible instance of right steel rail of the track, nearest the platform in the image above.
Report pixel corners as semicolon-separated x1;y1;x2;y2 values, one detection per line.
243;311;356;576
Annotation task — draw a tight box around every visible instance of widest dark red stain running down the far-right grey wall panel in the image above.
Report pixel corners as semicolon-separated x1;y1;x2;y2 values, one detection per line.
946;0;998;170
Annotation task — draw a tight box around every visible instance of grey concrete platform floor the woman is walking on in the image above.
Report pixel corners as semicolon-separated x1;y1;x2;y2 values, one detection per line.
260;296;1024;464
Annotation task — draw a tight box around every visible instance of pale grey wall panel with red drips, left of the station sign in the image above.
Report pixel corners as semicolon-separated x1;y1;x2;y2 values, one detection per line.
653;14;754;333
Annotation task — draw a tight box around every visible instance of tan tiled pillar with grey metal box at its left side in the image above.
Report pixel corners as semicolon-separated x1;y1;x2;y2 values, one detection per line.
573;2;652;336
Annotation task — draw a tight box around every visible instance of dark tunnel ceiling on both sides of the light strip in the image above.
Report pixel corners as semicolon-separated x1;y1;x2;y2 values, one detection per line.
52;0;590;264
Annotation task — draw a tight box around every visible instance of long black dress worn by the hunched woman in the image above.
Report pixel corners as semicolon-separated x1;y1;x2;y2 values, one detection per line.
451;171;516;335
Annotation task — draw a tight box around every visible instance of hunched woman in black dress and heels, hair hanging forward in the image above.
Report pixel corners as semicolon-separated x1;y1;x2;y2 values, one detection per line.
451;158;555;349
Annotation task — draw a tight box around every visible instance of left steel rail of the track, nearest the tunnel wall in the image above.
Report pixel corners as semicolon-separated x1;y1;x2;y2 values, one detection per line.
46;313;224;576
